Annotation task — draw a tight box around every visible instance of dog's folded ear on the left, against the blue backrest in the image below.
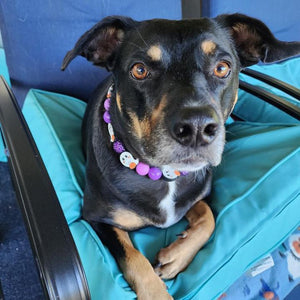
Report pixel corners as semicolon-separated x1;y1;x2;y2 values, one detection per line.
61;16;137;71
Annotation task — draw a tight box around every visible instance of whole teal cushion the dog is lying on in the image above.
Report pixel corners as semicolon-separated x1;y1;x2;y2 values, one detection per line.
23;80;300;300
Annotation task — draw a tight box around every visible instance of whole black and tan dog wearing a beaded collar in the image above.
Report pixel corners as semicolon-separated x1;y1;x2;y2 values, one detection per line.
62;14;300;300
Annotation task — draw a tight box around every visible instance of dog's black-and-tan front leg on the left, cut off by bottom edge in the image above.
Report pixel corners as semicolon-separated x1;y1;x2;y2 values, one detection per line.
91;222;173;300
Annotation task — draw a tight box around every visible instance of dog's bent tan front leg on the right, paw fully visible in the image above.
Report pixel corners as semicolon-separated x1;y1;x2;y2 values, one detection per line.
155;201;215;279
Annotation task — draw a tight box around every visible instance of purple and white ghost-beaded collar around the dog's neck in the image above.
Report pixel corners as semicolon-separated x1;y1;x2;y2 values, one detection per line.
103;86;187;181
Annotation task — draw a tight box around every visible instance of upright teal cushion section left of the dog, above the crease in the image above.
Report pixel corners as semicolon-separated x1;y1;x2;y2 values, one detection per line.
23;90;85;224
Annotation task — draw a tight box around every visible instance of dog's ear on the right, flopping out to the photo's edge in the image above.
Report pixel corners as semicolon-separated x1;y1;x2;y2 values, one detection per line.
215;14;300;67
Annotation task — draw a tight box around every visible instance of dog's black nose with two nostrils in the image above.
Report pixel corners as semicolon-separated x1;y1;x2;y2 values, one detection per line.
172;107;219;147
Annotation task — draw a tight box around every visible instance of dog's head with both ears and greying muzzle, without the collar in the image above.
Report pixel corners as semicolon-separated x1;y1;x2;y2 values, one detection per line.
62;14;300;171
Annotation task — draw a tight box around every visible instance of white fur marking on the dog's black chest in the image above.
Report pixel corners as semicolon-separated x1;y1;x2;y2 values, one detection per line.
159;181;178;228
